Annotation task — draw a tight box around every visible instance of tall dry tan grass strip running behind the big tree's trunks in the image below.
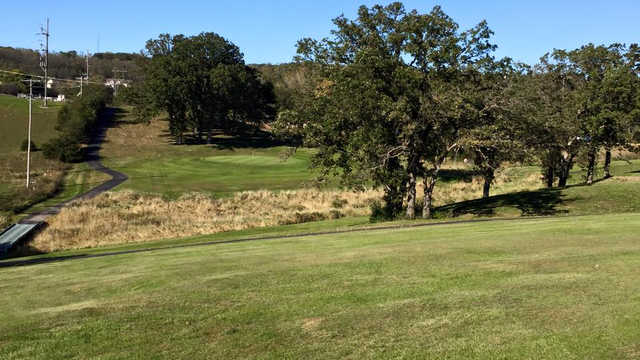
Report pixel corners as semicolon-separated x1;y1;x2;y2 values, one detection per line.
30;169;539;252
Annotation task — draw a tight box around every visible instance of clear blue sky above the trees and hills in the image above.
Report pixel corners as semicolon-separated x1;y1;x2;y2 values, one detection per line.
0;0;640;63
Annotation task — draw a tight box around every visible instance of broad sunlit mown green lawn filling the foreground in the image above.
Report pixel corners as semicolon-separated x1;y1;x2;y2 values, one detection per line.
0;214;640;359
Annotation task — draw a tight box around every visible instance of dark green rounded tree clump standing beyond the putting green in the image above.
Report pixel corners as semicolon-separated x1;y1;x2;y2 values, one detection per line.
140;33;275;144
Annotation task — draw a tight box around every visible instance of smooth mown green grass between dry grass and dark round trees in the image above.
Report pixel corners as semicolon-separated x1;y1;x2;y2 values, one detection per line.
105;145;314;196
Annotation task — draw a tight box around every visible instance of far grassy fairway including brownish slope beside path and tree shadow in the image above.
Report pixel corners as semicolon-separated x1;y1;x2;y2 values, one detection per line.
101;111;314;197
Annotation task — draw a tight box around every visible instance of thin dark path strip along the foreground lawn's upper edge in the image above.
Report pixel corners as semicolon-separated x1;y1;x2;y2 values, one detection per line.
0;215;589;268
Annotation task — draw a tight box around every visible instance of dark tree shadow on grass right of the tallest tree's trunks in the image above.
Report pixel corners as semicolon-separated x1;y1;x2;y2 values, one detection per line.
435;189;572;217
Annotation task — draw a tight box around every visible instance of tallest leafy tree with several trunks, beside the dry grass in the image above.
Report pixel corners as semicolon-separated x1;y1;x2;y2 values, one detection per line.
277;2;495;218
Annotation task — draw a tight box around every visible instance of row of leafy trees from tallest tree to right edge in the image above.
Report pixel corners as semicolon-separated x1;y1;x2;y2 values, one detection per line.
274;2;640;218
